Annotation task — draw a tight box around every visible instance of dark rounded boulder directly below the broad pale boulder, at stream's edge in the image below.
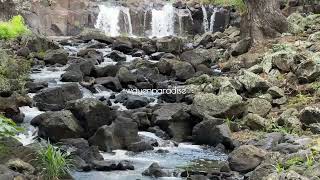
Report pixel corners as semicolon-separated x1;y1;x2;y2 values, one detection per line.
192;119;234;149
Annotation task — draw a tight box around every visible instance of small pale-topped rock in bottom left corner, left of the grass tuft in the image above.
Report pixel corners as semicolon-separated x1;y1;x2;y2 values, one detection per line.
6;159;35;175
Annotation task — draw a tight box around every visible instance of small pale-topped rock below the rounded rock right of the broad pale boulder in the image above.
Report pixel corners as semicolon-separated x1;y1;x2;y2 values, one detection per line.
243;113;267;130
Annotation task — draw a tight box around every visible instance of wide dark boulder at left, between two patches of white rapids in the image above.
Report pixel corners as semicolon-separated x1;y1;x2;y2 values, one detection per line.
33;83;82;111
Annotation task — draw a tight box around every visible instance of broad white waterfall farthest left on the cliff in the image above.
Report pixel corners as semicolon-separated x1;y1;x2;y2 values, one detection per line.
95;5;120;36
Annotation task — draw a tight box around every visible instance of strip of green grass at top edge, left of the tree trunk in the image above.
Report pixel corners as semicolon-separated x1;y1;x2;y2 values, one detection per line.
202;0;247;13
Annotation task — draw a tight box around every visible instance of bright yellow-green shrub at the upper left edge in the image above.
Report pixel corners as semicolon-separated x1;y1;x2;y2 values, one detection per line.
0;15;29;39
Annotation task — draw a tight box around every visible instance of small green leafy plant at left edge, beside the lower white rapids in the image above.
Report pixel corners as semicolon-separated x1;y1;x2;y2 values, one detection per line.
0;114;22;137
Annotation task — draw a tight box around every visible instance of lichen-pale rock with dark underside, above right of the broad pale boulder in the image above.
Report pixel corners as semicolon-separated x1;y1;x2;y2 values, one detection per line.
238;70;270;92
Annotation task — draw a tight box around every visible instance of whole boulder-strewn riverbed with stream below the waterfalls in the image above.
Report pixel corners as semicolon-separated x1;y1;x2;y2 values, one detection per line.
0;2;320;180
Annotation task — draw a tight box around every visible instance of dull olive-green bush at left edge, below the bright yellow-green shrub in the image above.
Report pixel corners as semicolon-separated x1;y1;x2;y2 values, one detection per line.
0;49;31;92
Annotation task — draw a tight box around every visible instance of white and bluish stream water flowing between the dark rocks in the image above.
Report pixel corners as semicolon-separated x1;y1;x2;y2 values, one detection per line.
13;40;227;180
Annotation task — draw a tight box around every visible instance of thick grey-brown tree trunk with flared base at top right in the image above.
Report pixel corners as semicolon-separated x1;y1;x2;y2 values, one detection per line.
241;0;288;43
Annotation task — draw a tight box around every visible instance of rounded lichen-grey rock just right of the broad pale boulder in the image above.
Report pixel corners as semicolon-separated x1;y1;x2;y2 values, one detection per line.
247;98;272;117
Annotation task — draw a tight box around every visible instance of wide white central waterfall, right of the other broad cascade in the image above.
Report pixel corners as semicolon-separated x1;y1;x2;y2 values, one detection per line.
151;4;175;37
